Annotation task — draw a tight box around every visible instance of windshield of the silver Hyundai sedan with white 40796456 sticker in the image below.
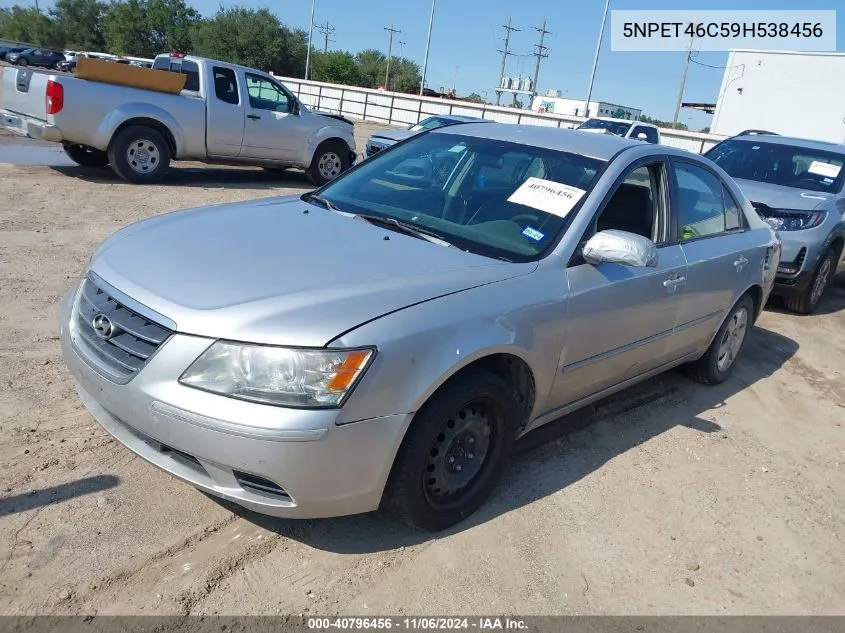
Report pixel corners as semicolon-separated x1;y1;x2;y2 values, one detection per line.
320;132;604;261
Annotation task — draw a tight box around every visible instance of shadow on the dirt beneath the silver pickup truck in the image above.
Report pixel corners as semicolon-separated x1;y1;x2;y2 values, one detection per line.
50;166;314;191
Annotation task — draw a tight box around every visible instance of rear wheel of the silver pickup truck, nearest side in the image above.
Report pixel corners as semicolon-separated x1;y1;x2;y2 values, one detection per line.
108;125;170;185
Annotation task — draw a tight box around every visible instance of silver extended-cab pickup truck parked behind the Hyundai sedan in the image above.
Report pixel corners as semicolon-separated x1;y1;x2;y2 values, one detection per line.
0;54;356;185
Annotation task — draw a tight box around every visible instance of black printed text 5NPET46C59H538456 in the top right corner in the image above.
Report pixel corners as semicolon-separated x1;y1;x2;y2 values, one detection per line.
622;22;824;38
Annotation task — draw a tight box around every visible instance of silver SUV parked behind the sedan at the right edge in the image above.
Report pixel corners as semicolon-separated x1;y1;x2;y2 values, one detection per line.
705;132;845;314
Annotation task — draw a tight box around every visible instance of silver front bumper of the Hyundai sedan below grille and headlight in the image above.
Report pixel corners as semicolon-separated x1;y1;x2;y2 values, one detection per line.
60;292;410;518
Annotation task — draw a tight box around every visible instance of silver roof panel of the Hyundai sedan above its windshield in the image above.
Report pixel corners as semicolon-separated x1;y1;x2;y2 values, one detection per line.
428;121;643;160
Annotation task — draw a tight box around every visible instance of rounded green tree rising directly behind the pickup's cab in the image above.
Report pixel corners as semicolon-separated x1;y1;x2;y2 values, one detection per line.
192;7;308;77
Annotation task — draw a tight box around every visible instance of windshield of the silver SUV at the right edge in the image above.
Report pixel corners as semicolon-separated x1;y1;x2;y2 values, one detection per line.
705;140;845;193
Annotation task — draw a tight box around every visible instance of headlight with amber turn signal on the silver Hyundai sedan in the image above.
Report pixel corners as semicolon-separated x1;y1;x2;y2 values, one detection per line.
179;341;374;408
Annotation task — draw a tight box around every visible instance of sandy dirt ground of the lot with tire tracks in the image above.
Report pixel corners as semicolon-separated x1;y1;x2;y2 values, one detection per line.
0;124;845;614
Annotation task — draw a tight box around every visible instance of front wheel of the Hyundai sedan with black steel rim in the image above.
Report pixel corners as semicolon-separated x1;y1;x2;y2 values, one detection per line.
385;370;520;531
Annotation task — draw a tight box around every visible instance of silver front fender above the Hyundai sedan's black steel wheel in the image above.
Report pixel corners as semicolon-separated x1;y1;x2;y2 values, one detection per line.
329;262;566;423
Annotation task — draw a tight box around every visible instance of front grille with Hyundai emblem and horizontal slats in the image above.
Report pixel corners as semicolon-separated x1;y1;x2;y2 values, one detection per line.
73;279;172;383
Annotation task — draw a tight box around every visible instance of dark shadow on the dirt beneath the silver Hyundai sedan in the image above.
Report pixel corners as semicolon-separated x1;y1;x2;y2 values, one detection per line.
218;327;798;554
